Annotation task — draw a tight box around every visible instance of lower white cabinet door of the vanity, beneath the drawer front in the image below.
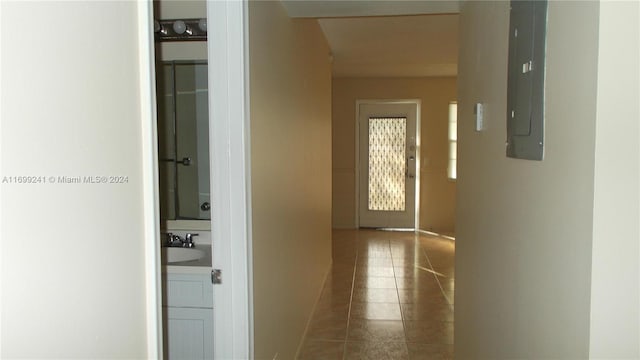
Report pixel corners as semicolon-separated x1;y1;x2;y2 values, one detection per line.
164;307;213;360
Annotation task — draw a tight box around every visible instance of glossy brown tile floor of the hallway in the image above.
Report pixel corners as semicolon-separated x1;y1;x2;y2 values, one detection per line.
299;230;455;360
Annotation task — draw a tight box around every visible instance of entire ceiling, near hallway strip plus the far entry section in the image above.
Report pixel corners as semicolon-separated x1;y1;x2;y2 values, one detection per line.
283;0;459;77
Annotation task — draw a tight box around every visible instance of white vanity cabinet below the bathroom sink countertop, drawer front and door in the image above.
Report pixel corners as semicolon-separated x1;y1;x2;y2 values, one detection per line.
162;272;213;360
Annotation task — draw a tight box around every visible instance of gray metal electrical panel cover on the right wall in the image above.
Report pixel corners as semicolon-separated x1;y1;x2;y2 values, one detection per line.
507;0;547;160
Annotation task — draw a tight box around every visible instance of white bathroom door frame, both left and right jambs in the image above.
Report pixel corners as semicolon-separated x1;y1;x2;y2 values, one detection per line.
146;0;254;359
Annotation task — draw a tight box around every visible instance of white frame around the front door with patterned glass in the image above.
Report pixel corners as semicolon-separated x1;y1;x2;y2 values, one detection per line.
354;99;422;231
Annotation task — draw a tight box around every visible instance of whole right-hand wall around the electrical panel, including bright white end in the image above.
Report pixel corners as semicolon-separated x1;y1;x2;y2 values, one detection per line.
455;2;638;359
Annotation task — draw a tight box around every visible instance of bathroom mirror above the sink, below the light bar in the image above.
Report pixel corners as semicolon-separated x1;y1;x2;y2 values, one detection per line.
156;61;211;221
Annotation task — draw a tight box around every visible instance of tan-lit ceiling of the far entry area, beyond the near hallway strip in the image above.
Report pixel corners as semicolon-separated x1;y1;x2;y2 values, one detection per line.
319;15;458;77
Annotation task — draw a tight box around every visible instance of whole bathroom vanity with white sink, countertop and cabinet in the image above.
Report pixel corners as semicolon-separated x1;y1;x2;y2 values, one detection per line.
162;232;213;360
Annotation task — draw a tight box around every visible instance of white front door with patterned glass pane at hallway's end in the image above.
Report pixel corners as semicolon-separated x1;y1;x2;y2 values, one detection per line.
358;102;418;229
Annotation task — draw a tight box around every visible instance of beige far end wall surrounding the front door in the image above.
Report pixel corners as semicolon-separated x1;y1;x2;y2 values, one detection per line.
332;77;457;233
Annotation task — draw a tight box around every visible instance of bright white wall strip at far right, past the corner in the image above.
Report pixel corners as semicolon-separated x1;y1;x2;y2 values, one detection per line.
590;1;640;359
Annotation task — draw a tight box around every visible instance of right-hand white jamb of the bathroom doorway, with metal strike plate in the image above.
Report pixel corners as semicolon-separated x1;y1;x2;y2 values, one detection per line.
207;0;254;359
